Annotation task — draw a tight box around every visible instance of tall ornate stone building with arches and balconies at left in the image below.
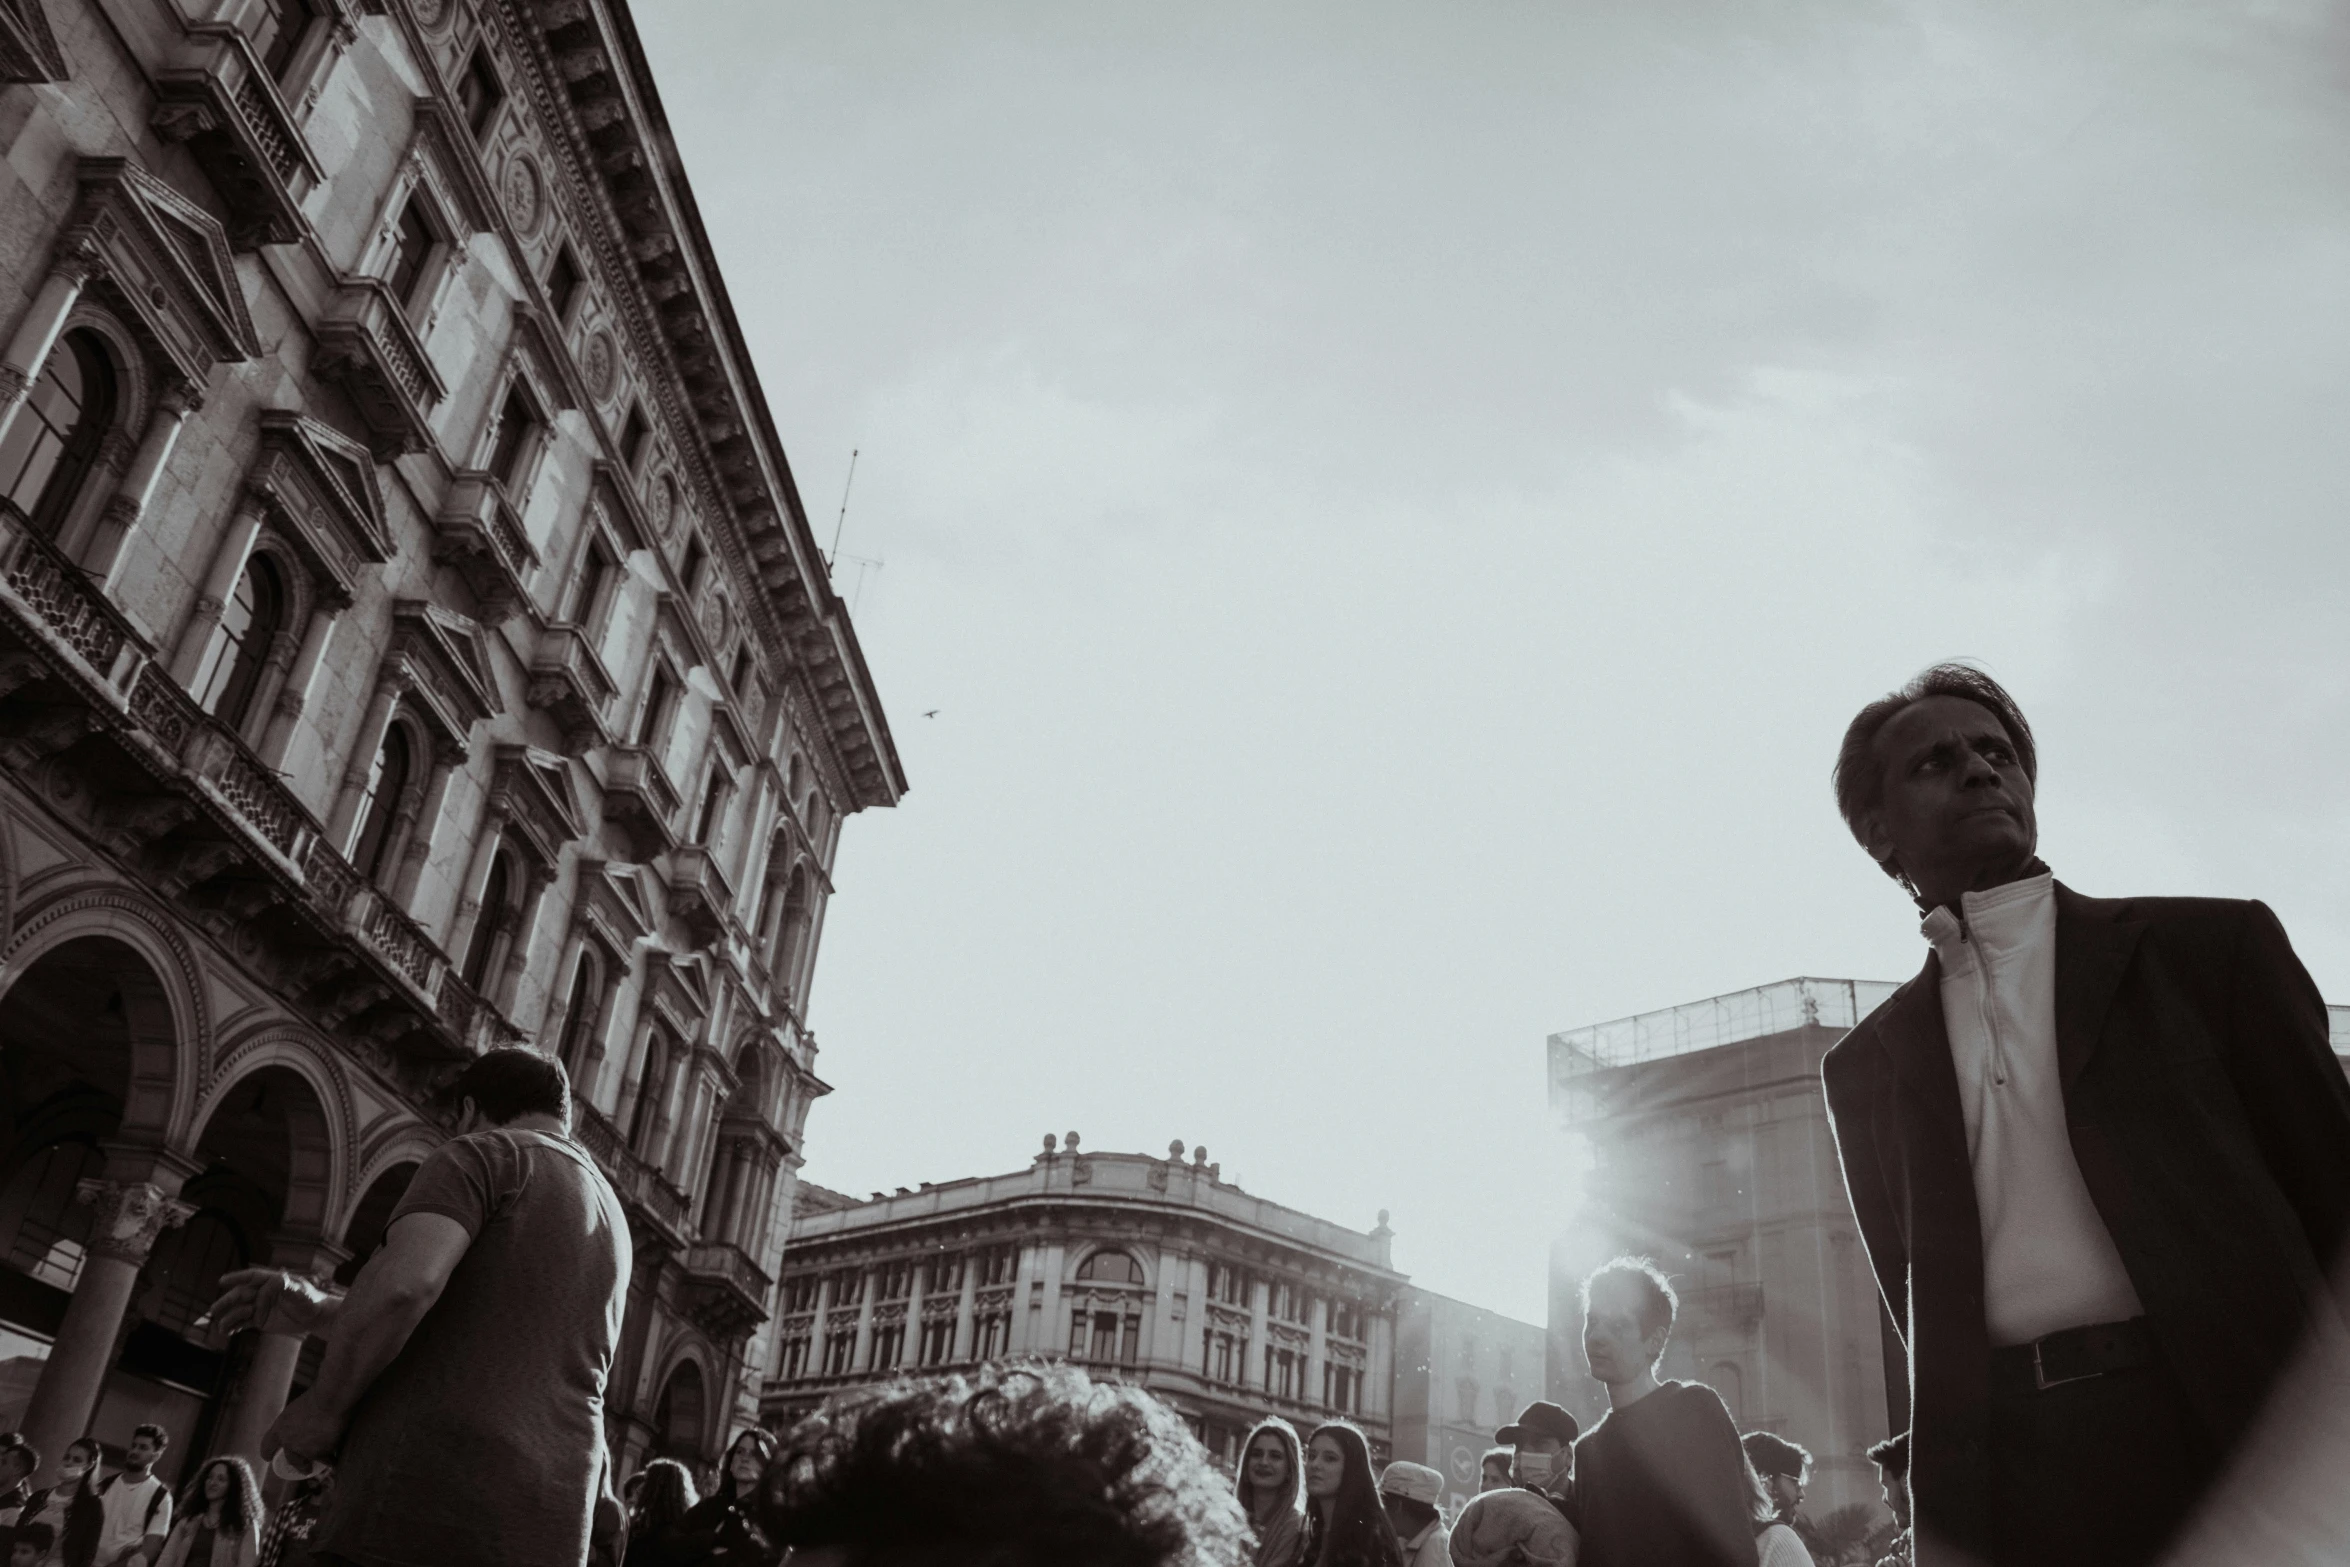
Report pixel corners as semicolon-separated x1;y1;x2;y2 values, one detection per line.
0;0;905;1494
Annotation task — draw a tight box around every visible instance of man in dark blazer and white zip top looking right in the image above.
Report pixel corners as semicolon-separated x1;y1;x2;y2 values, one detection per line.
1821;665;2350;1567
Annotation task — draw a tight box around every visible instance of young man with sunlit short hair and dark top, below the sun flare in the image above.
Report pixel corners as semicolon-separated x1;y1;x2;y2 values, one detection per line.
1575;1257;1755;1567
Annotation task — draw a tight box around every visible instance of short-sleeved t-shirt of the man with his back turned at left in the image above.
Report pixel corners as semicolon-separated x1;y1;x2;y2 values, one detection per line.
315;1130;630;1567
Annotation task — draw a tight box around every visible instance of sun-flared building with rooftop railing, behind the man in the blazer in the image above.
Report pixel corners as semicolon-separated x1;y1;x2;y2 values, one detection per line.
1549;980;1908;1515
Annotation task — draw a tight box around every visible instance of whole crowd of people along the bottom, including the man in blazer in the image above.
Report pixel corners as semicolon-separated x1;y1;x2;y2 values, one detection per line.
0;665;2350;1567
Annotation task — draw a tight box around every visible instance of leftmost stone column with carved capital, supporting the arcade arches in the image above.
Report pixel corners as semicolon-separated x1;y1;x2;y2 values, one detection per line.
24;1170;195;1475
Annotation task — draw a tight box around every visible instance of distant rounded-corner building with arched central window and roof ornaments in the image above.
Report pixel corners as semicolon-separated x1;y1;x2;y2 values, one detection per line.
761;1132;1403;1464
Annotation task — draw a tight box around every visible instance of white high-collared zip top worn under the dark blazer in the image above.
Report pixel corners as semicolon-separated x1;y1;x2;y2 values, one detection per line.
1925;872;2143;1346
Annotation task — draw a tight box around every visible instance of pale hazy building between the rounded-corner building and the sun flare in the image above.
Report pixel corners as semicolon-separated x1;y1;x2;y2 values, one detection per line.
1394;1287;1549;1518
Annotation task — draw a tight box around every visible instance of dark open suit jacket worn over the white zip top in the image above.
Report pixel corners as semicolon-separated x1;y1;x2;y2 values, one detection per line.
1821;883;2350;1562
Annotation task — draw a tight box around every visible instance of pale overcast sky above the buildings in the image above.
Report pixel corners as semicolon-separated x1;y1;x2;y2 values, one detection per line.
635;0;2350;1320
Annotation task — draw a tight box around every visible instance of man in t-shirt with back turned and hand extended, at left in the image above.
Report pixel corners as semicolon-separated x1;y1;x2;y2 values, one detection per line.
214;1048;630;1567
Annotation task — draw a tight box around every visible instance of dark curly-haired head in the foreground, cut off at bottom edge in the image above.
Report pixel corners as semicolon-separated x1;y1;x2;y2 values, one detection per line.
759;1360;1259;1567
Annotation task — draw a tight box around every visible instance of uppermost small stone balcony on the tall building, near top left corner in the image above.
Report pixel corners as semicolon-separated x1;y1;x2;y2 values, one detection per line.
153;21;320;251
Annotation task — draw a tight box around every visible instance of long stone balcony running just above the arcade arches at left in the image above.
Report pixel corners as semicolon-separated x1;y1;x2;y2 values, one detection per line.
0;505;519;1083
